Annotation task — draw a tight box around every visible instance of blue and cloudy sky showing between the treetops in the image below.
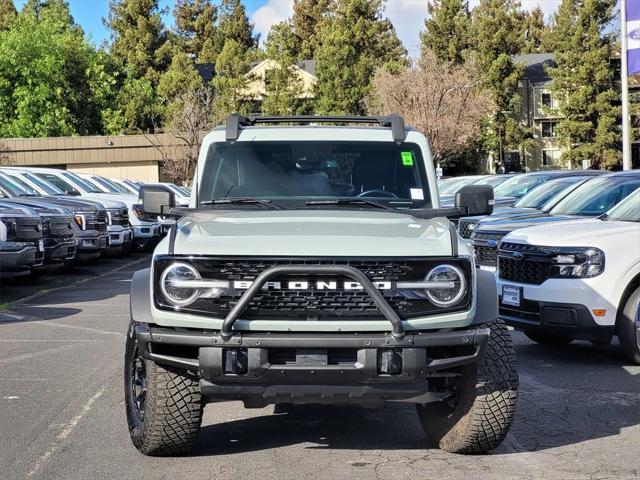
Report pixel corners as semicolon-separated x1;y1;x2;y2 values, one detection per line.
14;0;561;56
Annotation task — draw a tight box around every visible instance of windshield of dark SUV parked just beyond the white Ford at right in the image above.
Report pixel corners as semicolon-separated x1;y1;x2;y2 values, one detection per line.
549;175;640;217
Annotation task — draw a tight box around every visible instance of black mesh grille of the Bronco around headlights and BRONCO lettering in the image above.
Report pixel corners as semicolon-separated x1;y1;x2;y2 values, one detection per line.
154;257;471;320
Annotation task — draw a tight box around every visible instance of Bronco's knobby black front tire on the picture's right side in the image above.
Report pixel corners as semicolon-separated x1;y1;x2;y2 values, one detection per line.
417;320;518;454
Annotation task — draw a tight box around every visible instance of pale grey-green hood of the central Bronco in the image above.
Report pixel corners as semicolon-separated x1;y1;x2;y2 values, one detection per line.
174;210;457;257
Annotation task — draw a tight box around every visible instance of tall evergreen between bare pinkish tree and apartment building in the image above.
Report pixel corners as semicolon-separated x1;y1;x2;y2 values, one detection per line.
470;0;527;151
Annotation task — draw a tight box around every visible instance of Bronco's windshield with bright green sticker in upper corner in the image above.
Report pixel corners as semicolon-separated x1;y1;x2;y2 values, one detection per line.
199;141;431;208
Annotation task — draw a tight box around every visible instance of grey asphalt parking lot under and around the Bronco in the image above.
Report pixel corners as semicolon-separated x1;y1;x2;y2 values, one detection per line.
0;255;640;480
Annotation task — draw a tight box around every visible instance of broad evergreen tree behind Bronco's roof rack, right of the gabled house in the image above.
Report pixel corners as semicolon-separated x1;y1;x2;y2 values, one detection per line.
316;0;406;114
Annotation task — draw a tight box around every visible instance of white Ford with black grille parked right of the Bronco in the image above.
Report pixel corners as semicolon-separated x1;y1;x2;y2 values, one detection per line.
498;189;640;364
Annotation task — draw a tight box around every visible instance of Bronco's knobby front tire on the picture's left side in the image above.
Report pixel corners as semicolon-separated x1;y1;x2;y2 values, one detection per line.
124;328;204;456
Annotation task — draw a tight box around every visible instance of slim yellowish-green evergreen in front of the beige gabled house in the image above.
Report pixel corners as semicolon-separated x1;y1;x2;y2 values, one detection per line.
262;22;309;115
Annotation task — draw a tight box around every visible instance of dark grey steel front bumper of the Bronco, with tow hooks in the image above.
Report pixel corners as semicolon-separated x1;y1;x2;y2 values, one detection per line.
133;323;490;407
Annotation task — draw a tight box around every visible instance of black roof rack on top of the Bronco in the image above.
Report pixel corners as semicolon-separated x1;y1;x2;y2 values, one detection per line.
226;113;406;144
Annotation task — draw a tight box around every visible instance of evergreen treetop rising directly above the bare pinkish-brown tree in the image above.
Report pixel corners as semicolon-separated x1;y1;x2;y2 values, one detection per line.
420;0;471;64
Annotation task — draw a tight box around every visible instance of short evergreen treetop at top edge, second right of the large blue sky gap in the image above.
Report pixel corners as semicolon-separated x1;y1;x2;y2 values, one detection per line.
173;0;222;63
